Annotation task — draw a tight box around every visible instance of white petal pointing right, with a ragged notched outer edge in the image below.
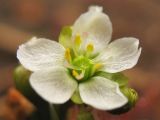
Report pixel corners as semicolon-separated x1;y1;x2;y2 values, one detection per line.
99;37;141;73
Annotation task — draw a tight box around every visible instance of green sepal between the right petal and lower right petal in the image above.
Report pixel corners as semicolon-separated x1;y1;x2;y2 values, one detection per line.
96;71;129;87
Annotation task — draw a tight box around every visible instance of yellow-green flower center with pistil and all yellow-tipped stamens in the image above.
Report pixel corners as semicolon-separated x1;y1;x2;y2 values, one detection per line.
65;35;102;81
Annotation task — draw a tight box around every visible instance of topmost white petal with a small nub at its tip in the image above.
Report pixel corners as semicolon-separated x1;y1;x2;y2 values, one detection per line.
73;6;112;50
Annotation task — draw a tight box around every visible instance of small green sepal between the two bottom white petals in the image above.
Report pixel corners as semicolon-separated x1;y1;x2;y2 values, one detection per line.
71;88;83;104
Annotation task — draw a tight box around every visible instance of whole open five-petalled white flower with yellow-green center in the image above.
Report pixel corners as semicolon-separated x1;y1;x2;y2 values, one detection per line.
17;6;141;110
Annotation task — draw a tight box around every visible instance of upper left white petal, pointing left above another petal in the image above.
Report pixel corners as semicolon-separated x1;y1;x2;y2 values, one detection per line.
17;37;65;71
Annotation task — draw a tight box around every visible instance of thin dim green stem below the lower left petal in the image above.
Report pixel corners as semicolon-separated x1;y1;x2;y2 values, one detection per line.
49;103;60;120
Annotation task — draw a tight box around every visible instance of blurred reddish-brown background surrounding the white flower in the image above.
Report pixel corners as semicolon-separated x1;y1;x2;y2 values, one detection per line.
0;0;160;120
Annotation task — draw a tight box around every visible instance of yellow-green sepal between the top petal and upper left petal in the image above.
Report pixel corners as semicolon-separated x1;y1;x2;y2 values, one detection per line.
59;26;72;48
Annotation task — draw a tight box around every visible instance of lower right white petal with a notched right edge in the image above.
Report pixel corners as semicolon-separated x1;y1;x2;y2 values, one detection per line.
79;77;128;110
